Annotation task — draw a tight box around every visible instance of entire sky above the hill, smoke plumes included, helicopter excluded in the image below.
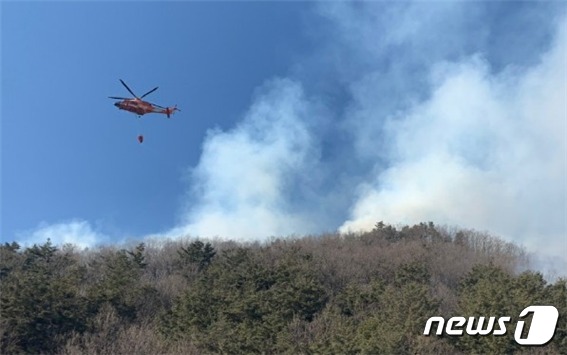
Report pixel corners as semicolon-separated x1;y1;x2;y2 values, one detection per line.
0;2;567;272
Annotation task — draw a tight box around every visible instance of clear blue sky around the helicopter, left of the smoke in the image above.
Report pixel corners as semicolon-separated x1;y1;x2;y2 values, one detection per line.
2;2;305;240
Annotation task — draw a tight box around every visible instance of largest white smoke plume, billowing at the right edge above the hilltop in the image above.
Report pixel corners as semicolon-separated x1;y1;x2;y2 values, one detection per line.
340;11;567;260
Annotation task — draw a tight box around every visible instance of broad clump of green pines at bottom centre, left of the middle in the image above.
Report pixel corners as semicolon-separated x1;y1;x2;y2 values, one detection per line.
162;248;326;353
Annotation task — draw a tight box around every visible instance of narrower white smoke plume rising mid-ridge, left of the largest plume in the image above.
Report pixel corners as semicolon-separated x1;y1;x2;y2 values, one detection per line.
170;79;326;240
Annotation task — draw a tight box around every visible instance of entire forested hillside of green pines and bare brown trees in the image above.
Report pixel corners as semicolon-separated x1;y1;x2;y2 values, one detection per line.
0;223;567;354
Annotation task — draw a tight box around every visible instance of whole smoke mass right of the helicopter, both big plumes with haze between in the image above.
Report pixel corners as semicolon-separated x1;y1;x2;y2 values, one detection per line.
172;3;567;264
